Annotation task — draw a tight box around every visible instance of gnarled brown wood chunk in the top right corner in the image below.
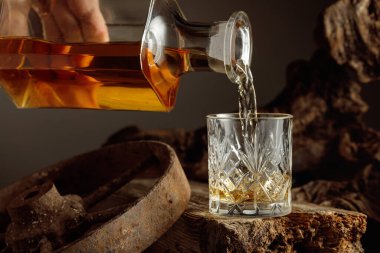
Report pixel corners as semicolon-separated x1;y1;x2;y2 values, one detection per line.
324;0;380;83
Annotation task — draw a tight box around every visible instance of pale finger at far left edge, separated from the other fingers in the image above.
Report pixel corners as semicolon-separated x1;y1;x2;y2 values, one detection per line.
0;0;31;36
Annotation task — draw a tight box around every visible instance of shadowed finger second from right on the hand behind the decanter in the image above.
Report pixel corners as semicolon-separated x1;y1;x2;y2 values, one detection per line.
50;0;84;43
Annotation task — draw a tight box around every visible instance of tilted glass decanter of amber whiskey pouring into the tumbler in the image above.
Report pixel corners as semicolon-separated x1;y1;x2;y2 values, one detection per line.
0;0;252;111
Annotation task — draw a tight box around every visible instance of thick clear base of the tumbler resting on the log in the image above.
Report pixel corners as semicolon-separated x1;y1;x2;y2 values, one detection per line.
209;199;292;217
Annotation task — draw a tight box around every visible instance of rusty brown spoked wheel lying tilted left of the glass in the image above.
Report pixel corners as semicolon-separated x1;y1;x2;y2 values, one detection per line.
0;142;190;252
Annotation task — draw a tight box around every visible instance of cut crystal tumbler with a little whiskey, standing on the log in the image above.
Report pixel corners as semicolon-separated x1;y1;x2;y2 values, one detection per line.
208;115;291;216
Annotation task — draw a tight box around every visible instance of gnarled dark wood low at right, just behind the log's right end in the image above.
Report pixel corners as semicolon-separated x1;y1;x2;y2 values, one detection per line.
293;165;380;252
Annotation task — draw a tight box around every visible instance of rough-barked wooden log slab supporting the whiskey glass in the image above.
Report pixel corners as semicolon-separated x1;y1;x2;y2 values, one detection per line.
139;181;366;252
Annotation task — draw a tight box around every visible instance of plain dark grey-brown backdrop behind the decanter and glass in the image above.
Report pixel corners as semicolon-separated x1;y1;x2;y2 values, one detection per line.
0;0;380;187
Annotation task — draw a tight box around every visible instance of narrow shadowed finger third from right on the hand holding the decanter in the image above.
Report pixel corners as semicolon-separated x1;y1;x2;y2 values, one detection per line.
32;0;63;42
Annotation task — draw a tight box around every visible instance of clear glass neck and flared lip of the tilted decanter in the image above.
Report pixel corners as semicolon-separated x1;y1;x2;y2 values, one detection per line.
176;12;252;81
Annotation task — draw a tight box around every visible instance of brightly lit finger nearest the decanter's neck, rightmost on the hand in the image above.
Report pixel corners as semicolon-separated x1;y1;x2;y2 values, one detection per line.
67;0;109;42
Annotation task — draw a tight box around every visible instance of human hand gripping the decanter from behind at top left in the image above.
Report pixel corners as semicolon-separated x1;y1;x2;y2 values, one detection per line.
0;0;109;43
